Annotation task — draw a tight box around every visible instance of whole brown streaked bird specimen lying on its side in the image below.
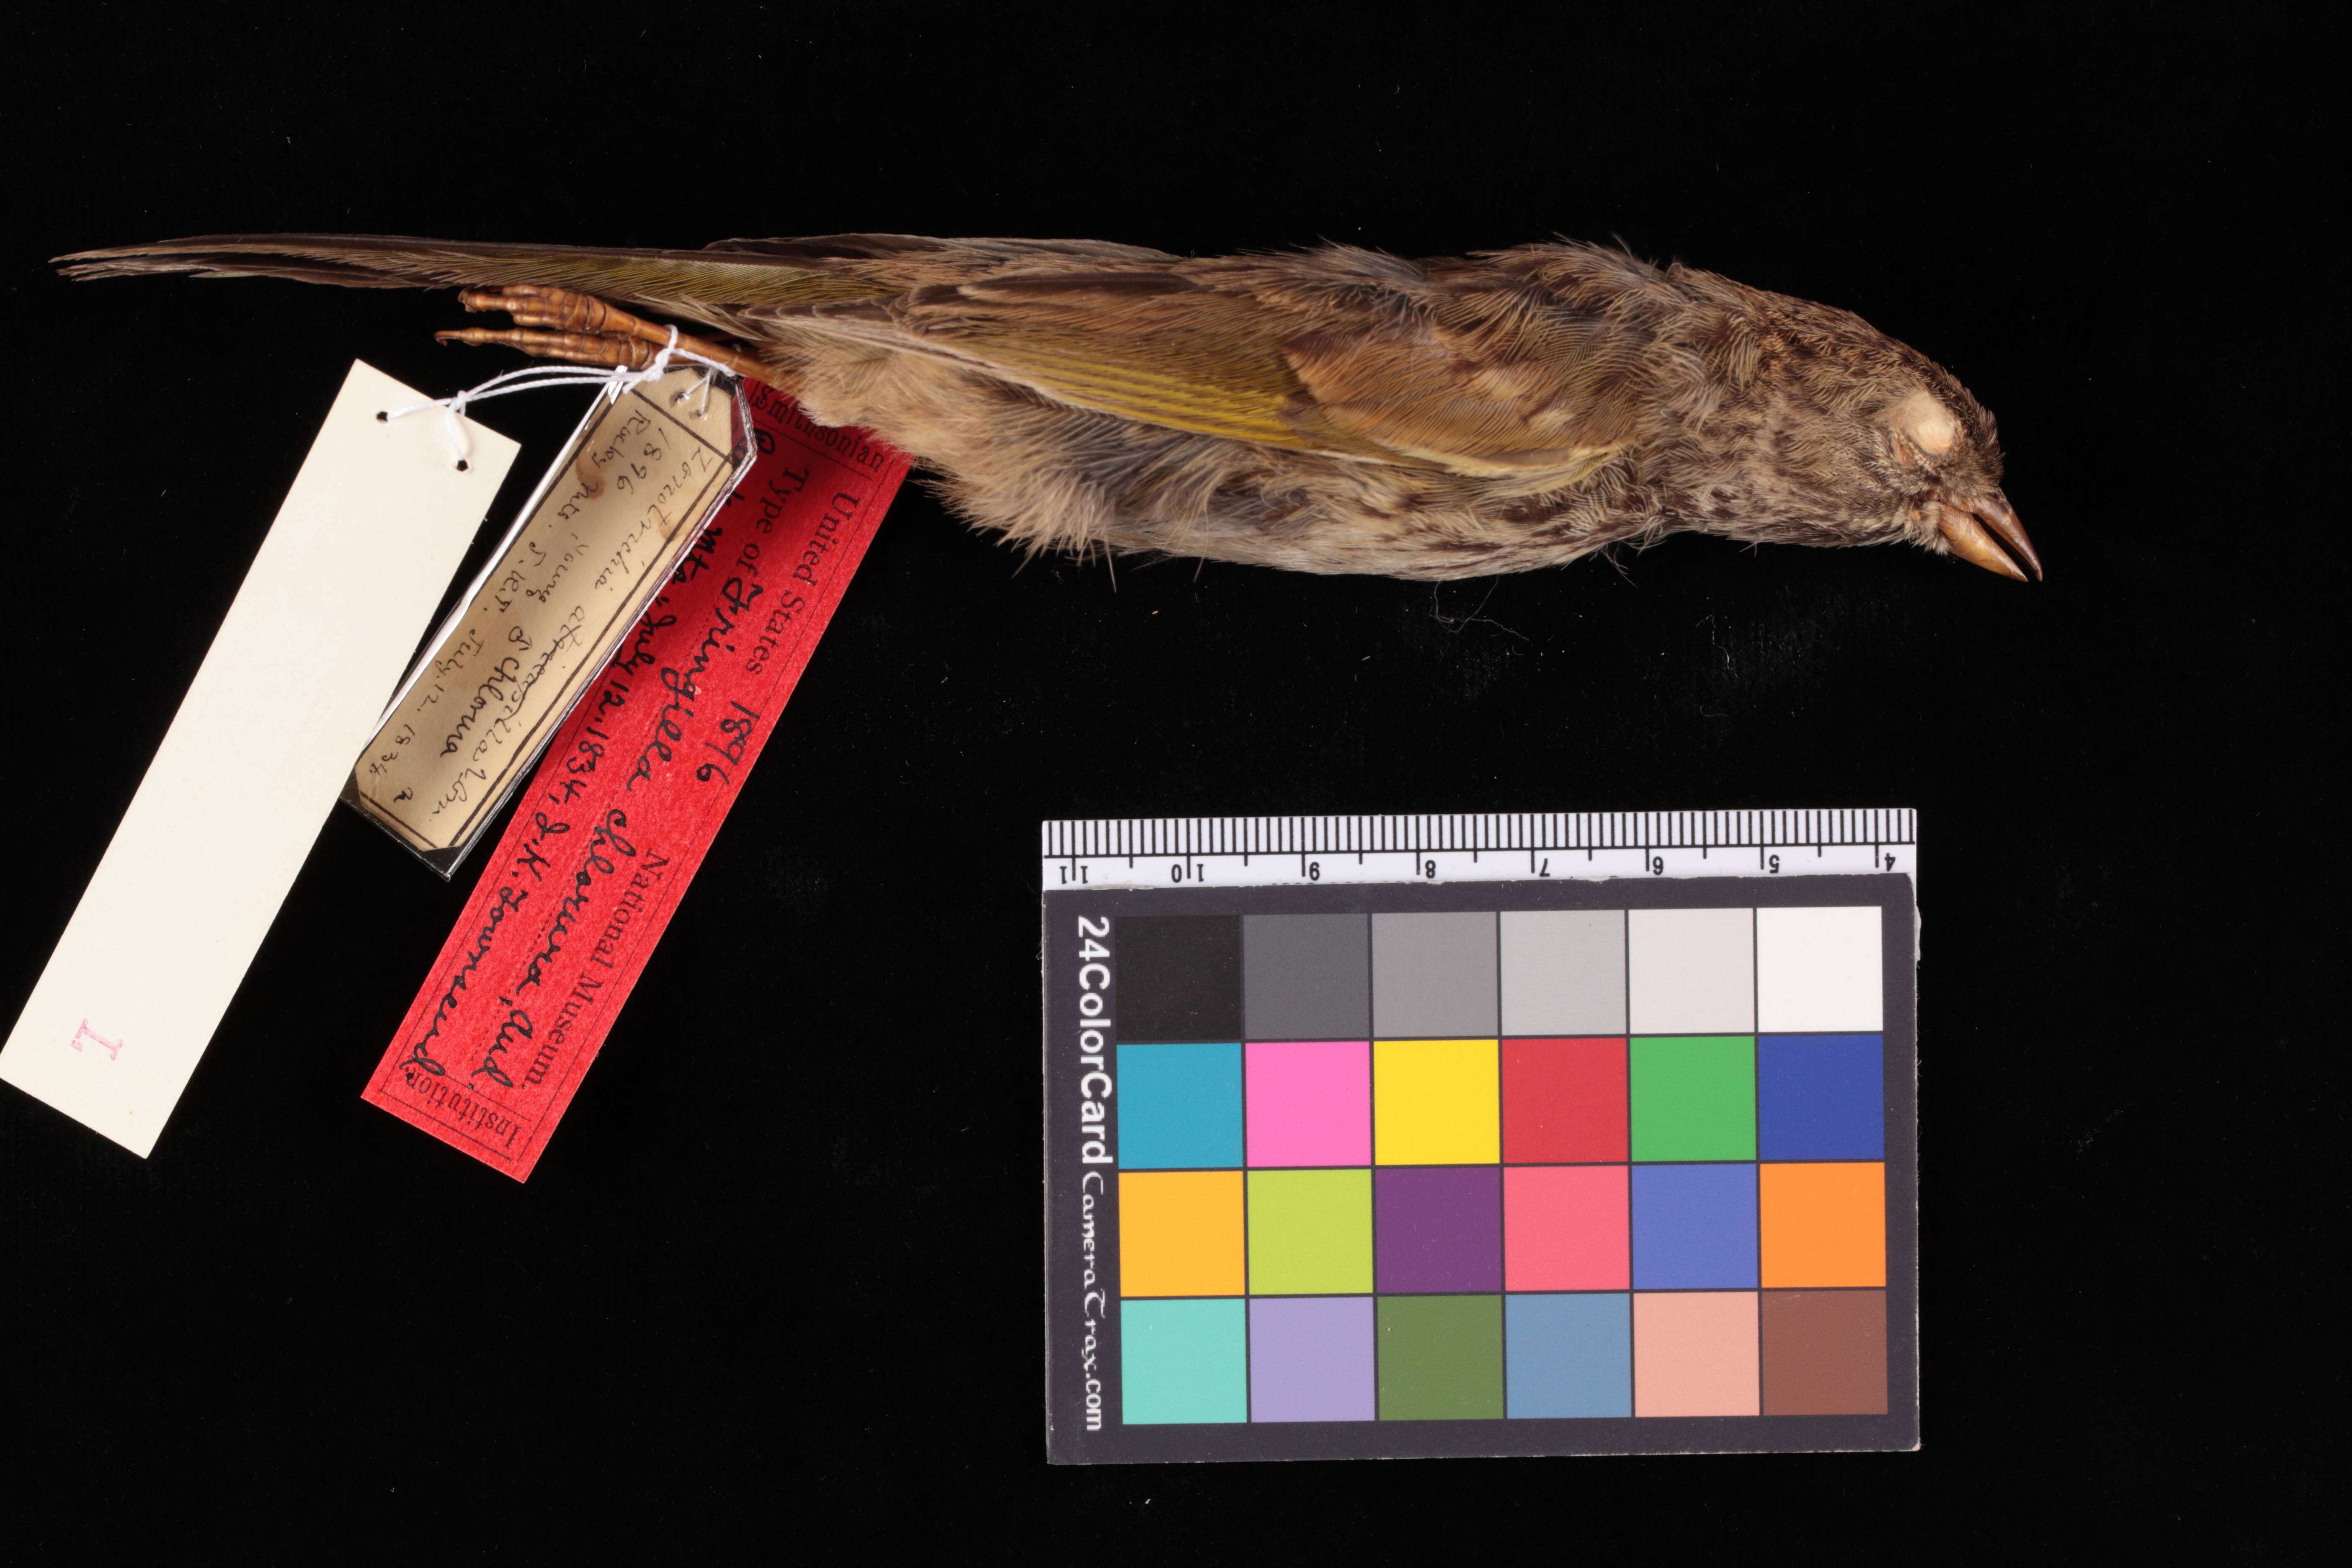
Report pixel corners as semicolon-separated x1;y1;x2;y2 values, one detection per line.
59;235;2042;580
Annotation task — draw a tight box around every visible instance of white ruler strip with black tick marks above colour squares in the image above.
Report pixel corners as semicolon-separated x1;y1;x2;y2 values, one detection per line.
1039;809;1919;891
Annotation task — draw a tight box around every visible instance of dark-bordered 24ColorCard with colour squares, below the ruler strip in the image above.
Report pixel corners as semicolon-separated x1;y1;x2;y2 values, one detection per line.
1044;874;1917;1462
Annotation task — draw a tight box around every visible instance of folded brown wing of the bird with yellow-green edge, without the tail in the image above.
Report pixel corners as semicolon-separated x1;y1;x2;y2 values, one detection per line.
755;247;1644;482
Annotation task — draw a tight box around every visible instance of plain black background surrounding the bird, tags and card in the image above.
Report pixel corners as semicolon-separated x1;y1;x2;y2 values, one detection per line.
0;3;2343;1561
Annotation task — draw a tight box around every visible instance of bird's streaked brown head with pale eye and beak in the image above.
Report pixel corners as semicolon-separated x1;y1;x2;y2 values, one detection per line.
1677;296;2042;583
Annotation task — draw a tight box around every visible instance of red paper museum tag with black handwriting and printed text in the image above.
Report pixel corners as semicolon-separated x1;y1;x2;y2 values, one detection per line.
364;383;905;1180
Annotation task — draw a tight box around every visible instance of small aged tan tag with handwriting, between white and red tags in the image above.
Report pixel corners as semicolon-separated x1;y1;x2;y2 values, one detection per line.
346;369;750;877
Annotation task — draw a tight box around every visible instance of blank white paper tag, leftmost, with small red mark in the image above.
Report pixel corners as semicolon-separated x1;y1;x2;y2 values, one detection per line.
0;364;515;1157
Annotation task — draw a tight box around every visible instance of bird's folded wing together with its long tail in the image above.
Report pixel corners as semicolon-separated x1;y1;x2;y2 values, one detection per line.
59;235;1644;484
